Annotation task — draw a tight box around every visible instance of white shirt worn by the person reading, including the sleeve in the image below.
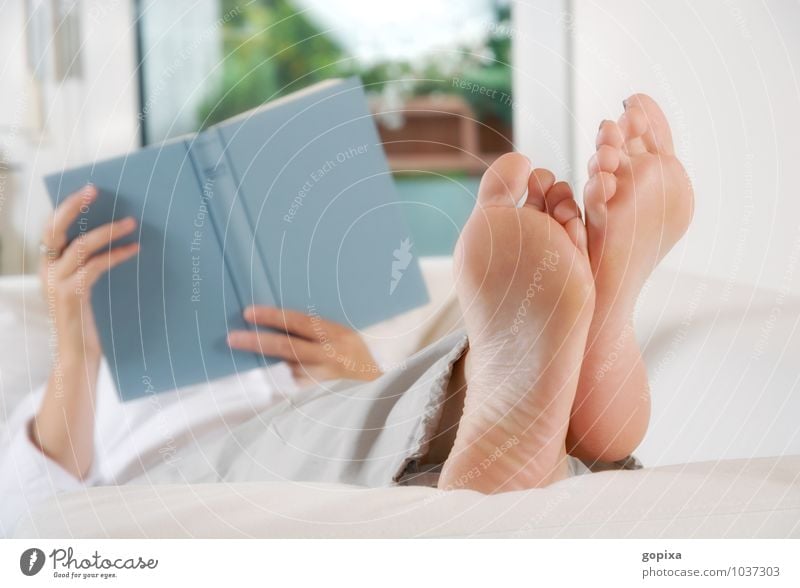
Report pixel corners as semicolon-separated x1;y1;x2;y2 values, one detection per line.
0;361;297;537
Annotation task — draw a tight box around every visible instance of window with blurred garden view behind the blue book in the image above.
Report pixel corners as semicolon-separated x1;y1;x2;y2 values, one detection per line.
138;0;512;255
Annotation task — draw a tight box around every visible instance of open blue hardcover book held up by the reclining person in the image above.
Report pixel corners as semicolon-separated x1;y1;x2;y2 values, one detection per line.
45;78;428;400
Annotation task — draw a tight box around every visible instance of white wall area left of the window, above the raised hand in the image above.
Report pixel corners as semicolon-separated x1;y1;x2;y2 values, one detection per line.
0;0;139;273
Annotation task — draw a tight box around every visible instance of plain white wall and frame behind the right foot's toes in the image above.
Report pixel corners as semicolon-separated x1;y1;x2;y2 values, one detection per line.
515;0;800;293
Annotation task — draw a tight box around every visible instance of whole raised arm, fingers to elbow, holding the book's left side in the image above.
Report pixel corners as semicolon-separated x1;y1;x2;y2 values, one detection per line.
28;186;139;478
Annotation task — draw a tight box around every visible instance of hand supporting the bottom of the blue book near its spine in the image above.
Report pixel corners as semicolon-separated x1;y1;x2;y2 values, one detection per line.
228;306;382;383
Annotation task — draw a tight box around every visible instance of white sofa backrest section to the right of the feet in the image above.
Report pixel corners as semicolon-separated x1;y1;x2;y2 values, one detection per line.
636;271;800;467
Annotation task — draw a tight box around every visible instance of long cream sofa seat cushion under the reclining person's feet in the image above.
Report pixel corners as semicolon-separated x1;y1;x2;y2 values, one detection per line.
15;457;800;538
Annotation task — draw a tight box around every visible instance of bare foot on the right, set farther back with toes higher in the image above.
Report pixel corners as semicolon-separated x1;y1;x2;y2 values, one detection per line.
568;94;694;461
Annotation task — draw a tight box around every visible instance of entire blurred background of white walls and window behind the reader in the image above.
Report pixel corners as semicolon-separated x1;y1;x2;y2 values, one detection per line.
0;0;800;292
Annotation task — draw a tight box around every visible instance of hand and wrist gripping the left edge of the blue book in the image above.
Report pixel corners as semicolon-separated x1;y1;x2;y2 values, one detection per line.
39;186;139;358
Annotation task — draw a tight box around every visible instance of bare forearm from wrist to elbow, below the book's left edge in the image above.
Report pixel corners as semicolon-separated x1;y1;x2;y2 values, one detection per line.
30;353;100;479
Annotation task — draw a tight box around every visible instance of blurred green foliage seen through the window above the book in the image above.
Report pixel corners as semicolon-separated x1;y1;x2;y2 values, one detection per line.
197;0;512;127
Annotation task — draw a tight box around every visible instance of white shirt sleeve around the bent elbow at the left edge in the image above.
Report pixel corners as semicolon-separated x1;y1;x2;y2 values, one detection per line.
0;395;91;537
